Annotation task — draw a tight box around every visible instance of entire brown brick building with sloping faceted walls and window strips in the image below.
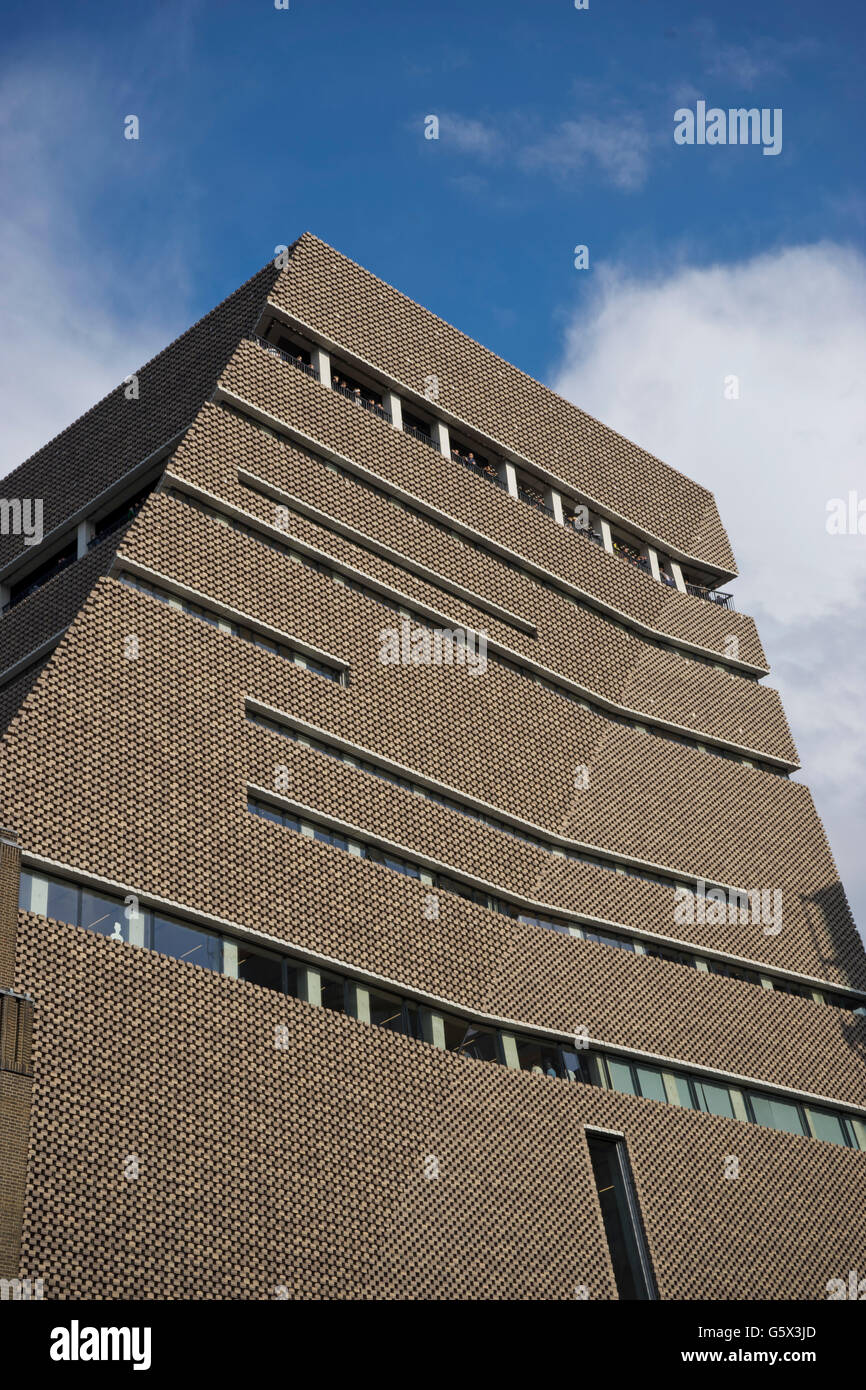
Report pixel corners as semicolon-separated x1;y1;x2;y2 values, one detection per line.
0;235;866;1300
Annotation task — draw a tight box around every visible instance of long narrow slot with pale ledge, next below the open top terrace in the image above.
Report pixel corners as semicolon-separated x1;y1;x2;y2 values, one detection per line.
220;400;760;682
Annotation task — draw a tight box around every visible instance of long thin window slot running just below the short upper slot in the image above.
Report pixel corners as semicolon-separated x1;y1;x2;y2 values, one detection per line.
170;467;787;776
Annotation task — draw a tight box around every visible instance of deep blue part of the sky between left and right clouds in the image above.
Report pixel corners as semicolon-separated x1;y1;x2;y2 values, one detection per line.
1;0;865;375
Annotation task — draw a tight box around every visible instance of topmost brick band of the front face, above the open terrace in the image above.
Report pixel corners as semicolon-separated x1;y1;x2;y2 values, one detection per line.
270;234;735;570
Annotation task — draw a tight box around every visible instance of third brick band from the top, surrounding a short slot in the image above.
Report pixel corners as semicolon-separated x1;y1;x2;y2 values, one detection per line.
167;403;796;762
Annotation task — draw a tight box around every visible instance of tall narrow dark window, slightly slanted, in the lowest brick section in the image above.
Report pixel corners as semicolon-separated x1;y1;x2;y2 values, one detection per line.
587;1131;659;1300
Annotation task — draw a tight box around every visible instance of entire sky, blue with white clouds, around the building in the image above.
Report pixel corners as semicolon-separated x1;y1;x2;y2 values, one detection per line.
0;0;866;939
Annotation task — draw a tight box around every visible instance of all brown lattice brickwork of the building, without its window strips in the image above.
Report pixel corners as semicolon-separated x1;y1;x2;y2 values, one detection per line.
0;236;866;1300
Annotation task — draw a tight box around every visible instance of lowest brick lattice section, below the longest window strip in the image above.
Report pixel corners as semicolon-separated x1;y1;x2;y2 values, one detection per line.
13;923;866;1300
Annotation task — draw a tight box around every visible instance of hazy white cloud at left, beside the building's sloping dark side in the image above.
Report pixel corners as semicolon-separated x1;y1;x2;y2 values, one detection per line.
0;57;183;477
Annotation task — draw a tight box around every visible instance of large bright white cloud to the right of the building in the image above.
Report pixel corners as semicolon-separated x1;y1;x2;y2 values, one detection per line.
553;243;866;945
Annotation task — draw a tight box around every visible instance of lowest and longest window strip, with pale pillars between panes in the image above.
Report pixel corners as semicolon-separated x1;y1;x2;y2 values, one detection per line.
18;870;866;1151
